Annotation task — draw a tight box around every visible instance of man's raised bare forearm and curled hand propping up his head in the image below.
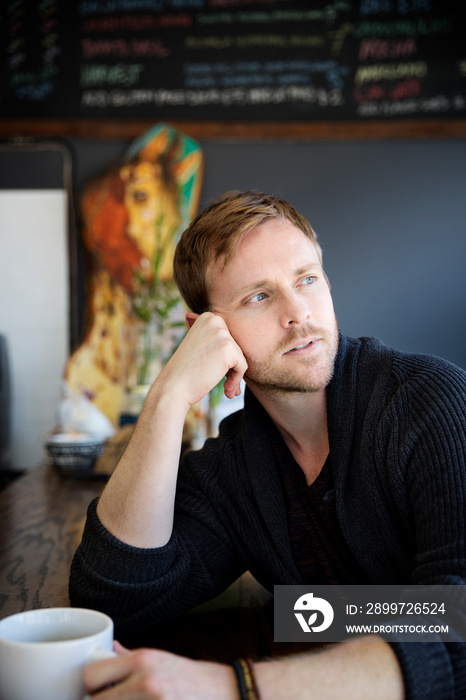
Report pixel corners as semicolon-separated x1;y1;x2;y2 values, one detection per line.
93;313;247;548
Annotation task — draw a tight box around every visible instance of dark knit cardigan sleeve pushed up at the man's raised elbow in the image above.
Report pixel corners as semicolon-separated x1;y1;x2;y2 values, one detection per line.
69;440;246;644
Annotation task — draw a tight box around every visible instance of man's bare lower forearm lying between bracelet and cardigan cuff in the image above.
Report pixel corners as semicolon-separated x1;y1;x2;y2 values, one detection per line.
255;636;405;700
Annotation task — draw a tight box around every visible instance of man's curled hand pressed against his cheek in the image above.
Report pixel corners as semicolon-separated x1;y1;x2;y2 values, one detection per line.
156;312;248;408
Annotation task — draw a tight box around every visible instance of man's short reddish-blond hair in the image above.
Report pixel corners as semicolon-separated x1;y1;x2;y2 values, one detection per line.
173;190;322;314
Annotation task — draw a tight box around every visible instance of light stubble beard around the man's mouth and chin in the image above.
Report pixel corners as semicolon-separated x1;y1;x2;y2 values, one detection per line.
244;319;338;395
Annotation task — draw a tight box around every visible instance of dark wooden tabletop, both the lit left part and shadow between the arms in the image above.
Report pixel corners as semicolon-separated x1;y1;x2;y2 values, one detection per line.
0;464;315;661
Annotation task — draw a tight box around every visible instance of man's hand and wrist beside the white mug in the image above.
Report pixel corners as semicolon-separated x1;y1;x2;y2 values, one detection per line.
84;642;238;700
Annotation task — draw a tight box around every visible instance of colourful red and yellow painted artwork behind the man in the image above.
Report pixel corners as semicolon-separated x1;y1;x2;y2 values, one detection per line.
65;124;203;423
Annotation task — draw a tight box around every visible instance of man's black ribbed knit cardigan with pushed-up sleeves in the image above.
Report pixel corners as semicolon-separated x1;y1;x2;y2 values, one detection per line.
70;335;466;700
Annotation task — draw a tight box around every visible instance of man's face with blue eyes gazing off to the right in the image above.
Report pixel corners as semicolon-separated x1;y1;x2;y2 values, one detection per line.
208;219;338;393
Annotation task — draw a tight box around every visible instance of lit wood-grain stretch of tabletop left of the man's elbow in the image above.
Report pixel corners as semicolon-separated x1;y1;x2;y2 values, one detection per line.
0;463;105;619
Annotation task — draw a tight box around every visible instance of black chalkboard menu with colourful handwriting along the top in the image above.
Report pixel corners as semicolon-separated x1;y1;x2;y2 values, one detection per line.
0;0;466;122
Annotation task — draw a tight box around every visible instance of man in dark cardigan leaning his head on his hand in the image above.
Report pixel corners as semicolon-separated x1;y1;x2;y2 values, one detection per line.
70;192;466;700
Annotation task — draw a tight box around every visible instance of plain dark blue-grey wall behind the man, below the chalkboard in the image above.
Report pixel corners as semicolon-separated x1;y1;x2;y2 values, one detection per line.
68;133;466;368
